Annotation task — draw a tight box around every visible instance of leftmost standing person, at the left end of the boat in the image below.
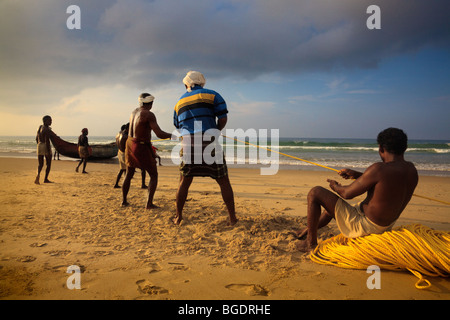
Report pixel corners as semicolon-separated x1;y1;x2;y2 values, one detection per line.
34;116;56;184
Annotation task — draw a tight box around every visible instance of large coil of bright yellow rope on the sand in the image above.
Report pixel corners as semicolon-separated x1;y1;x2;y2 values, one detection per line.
310;224;450;289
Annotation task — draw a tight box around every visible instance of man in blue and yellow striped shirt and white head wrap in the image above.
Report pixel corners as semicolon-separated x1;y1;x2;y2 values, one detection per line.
173;71;237;225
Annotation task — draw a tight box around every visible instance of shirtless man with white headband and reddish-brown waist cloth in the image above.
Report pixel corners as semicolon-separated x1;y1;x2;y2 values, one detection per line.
122;93;172;209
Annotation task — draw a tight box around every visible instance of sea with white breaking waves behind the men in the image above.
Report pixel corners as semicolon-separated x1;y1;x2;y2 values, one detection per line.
0;136;450;176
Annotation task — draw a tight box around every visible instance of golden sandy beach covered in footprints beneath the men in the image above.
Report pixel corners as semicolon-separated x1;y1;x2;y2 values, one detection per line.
0;158;450;300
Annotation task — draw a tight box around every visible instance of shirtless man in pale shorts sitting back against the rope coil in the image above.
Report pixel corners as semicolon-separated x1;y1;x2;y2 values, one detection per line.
297;128;418;252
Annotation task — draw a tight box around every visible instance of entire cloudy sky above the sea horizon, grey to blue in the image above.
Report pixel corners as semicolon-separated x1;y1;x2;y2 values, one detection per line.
0;0;450;140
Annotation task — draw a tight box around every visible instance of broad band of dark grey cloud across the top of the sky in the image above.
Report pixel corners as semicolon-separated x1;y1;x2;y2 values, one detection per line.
0;0;450;109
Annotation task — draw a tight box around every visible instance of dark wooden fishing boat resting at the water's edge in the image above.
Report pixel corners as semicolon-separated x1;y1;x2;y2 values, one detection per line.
51;137;118;160
